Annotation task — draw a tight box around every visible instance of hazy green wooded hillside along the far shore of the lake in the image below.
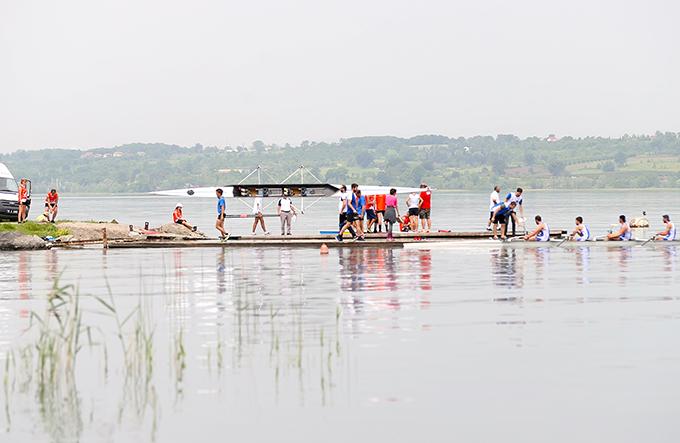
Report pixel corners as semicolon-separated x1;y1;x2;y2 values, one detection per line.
0;132;680;192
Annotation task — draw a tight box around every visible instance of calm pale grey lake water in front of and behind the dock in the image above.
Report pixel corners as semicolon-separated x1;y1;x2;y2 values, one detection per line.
0;191;680;442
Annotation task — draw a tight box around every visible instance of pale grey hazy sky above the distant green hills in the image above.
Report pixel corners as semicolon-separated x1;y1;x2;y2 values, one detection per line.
0;0;680;152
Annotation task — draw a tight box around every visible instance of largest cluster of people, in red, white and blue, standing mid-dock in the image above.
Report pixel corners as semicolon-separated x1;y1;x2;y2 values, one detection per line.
335;183;432;241
